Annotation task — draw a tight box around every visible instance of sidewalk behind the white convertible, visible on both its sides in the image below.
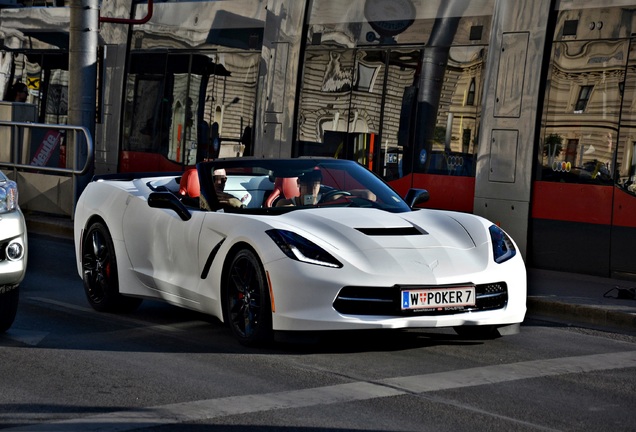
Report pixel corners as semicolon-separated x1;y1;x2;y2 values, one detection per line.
25;214;636;334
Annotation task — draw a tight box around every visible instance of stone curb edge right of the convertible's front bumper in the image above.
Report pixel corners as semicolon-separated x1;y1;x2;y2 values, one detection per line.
527;296;636;331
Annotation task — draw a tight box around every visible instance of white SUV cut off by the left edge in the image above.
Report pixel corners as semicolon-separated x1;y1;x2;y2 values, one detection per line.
0;171;27;332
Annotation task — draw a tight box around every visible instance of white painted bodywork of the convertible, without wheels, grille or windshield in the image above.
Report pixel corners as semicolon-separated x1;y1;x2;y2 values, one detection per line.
74;160;526;331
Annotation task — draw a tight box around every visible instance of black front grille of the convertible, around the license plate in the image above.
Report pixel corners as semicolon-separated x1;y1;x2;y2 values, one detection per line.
333;282;508;316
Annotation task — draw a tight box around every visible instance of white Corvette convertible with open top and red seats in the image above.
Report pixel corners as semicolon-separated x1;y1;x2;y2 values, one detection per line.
74;158;526;344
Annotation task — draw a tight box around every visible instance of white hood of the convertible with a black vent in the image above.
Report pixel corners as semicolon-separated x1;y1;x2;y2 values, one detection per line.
270;208;488;282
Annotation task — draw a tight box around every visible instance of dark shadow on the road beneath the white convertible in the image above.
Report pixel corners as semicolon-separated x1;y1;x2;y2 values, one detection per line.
0;298;516;355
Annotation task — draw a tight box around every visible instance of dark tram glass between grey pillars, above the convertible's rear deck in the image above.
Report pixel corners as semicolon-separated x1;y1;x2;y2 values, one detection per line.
123;49;260;165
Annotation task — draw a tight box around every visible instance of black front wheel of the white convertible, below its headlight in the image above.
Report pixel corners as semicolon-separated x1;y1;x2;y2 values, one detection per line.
223;249;273;346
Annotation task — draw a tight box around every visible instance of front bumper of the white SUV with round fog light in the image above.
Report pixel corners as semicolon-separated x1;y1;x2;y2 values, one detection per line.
0;210;28;291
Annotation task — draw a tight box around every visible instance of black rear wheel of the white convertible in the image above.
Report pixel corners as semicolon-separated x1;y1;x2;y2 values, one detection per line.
82;222;142;312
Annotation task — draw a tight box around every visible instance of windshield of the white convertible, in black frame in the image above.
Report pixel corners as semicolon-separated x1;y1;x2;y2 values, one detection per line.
197;158;410;213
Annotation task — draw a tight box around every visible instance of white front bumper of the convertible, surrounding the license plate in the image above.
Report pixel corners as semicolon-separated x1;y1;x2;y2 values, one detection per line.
266;253;527;331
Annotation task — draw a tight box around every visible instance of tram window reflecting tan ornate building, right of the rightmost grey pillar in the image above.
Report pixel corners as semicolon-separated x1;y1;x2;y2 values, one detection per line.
539;40;628;185
